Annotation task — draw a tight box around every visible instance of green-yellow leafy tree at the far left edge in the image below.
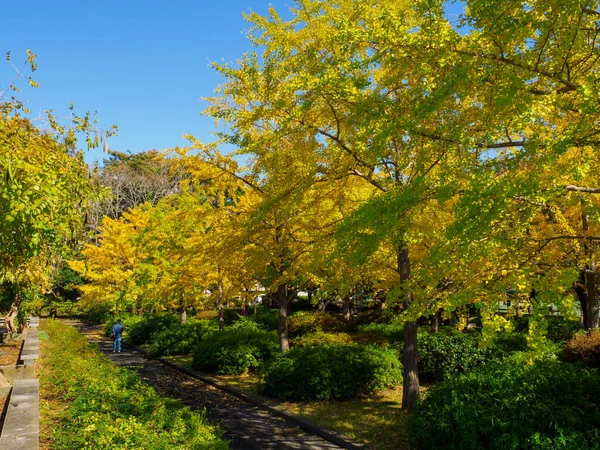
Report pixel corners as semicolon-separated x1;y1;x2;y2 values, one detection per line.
0;50;116;332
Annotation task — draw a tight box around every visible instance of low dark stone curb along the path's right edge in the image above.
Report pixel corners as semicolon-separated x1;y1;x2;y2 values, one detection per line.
123;342;369;450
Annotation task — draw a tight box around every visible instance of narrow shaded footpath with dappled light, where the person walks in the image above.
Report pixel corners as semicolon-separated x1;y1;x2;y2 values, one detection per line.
65;321;341;450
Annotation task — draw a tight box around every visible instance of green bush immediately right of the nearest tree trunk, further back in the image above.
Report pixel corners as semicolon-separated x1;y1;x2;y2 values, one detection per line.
412;331;498;383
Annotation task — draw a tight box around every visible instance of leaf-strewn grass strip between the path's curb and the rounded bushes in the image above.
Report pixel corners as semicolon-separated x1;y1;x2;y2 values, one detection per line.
165;356;410;450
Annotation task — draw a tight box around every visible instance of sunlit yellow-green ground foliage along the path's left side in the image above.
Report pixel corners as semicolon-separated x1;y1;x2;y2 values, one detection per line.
39;320;227;450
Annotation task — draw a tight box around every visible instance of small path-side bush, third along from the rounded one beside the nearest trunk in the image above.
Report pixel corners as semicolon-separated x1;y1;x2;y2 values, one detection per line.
150;320;218;356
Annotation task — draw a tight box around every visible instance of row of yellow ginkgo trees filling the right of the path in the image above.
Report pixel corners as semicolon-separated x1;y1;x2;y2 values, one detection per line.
34;0;600;409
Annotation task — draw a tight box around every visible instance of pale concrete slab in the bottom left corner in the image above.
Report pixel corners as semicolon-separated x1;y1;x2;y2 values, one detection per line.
0;379;40;450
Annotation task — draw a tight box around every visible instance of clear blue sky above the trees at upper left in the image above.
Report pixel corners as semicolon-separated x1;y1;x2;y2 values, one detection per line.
0;0;464;163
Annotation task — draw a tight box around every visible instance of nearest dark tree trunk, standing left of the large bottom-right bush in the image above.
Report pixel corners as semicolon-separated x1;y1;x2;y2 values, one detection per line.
397;243;419;411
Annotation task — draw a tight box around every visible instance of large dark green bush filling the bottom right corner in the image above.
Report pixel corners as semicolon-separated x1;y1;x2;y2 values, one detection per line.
409;360;600;450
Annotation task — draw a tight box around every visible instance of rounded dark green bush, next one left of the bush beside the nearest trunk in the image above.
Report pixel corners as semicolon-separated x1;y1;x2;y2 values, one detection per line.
192;324;279;375
